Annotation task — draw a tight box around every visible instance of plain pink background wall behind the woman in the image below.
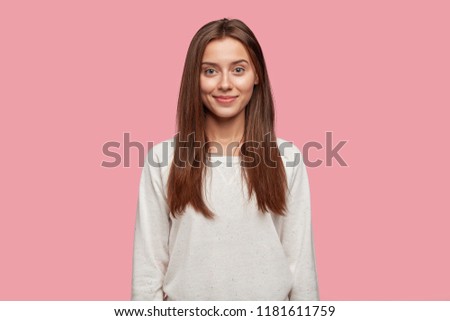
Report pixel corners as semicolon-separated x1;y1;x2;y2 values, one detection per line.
0;1;450;300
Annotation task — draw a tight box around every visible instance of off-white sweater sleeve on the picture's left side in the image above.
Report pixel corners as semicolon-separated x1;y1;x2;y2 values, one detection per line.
131;151;170;301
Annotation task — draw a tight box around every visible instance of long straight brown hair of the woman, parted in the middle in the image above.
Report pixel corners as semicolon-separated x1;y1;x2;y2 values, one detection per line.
167;18;287;218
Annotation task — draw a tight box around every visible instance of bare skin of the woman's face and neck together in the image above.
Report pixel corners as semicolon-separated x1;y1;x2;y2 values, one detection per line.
200;37;258;156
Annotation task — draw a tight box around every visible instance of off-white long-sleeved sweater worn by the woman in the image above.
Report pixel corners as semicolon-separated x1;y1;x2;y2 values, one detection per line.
131;138;319;301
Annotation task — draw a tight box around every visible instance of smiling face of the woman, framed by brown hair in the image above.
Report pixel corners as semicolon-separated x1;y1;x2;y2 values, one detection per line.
200;37;258;118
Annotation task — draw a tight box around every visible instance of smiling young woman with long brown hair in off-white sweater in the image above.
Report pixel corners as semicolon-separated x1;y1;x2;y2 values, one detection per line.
132;19;319;301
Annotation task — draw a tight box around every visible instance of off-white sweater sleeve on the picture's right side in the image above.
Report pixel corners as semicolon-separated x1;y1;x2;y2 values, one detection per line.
281;148;319;301
